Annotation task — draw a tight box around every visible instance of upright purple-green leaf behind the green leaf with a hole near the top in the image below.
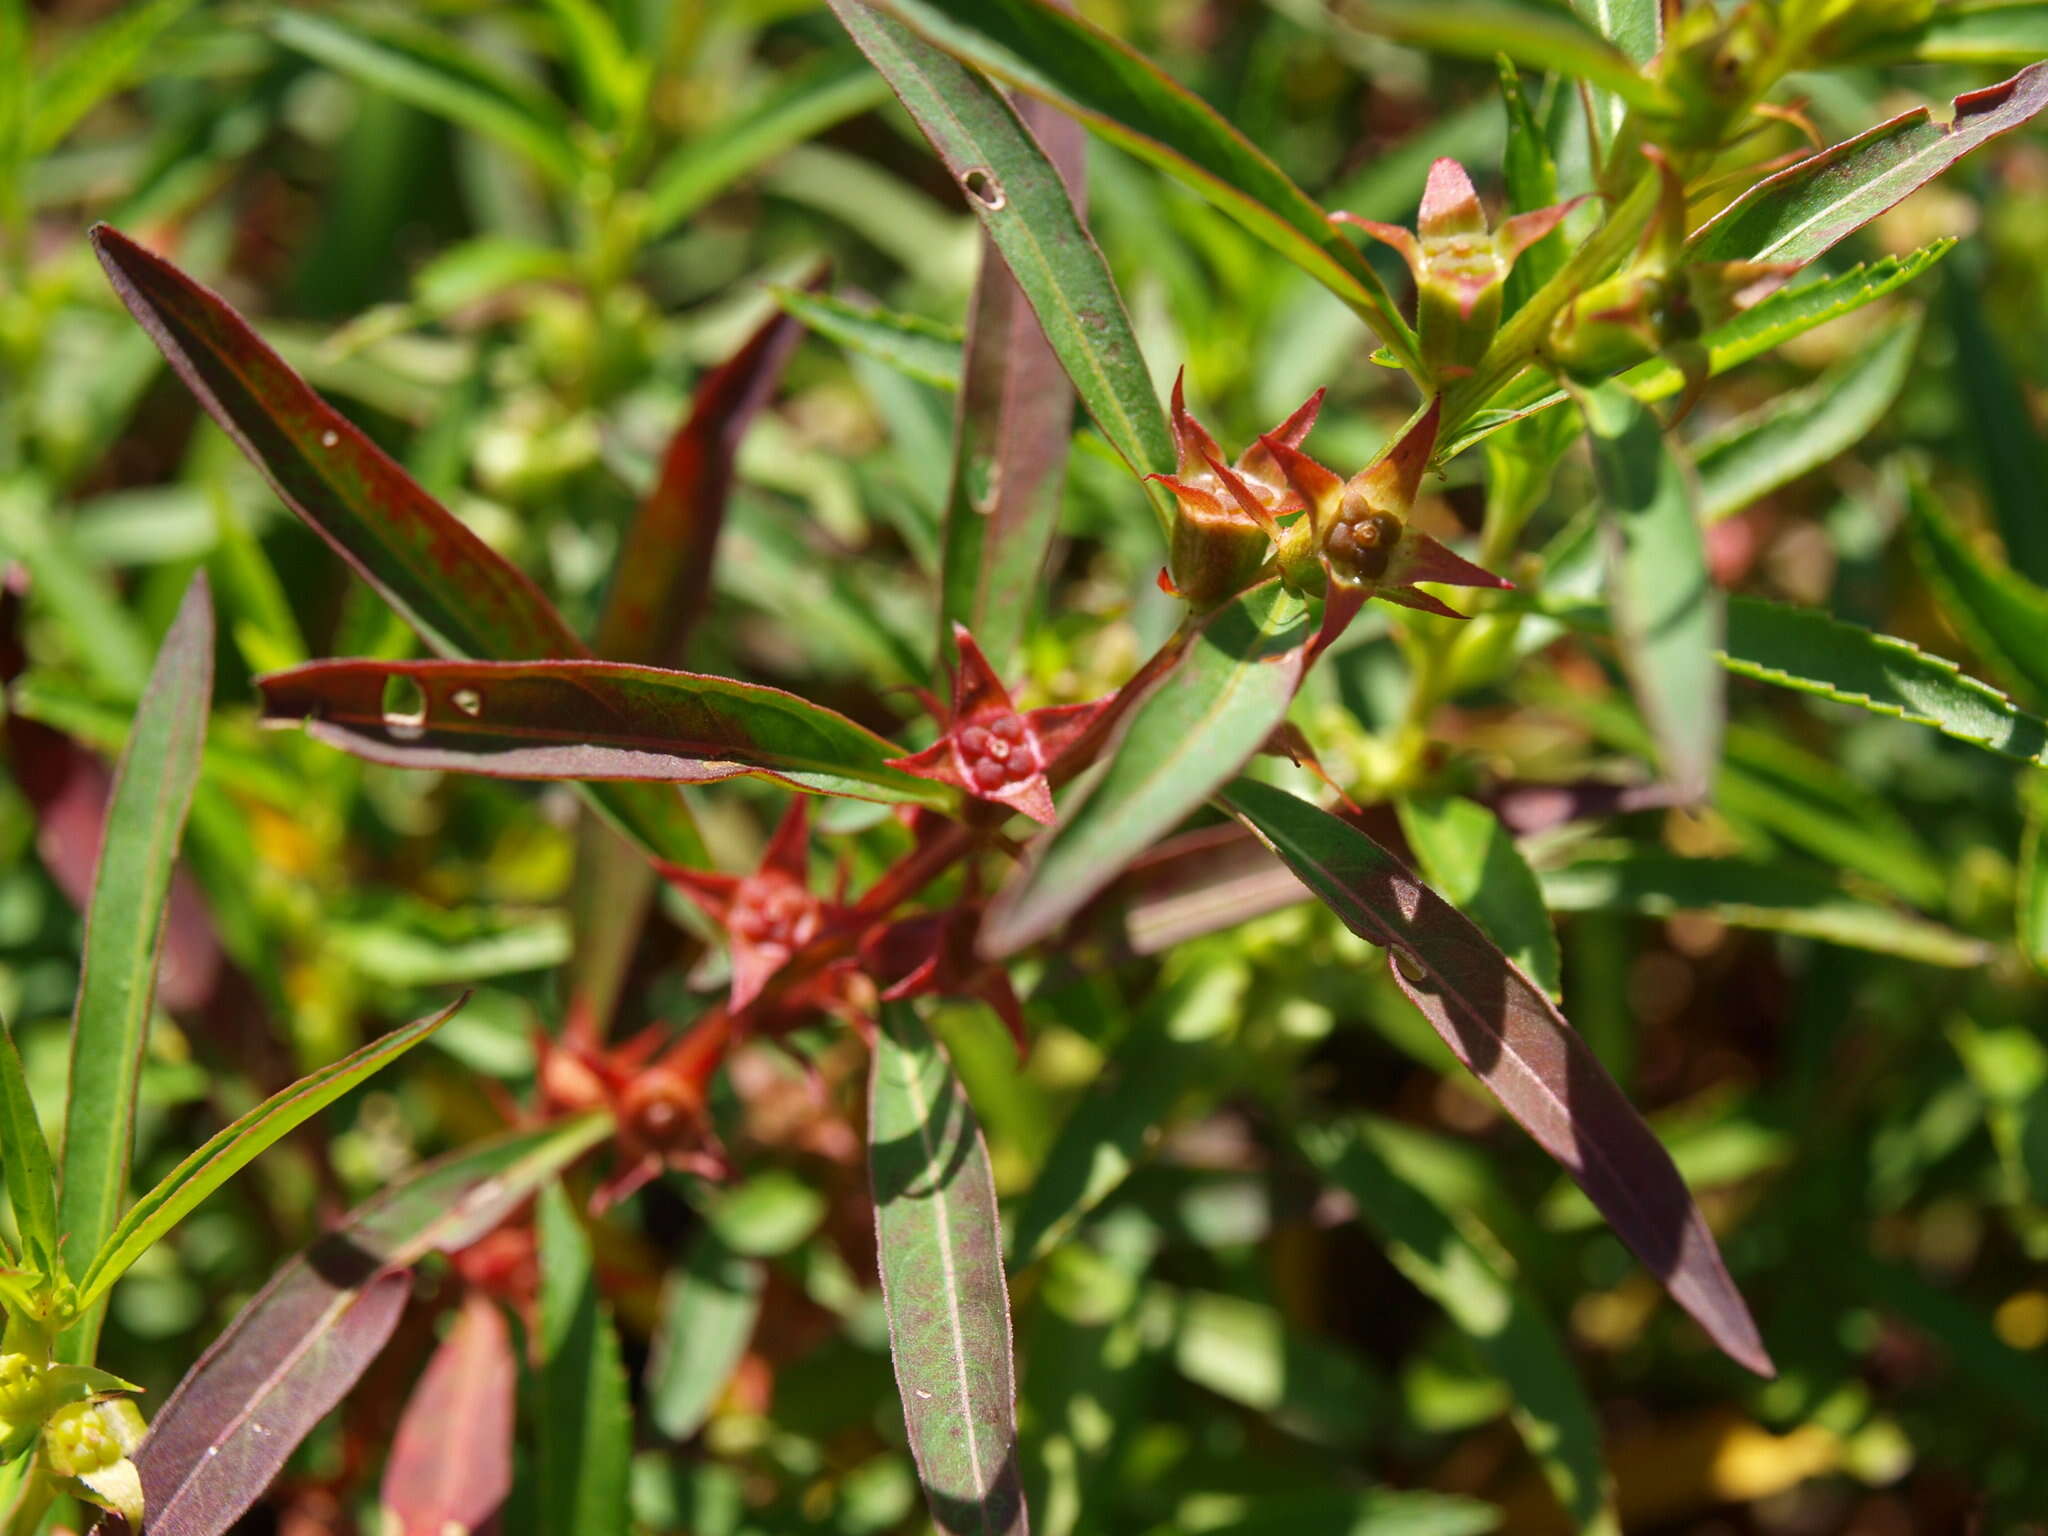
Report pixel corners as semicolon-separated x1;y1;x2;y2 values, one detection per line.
938;76;1089;672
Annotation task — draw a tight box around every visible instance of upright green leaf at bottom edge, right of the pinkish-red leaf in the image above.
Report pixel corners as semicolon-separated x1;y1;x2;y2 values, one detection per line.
537;1182;633;1536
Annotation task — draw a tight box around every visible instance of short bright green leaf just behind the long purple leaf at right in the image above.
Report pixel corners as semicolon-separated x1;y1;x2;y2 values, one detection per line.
1397;795;1563;997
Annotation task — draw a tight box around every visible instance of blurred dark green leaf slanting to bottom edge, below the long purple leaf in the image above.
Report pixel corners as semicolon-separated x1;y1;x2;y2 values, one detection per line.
1296;1120;1620;1536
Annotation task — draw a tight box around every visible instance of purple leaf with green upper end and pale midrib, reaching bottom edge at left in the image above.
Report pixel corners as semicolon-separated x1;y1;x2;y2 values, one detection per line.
135;1116;610;1536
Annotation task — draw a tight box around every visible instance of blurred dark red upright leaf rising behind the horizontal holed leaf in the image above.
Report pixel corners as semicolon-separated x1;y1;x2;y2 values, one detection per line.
593;290;806;666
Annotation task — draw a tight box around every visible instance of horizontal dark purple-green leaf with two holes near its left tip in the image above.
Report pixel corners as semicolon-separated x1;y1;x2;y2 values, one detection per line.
256;662;952;807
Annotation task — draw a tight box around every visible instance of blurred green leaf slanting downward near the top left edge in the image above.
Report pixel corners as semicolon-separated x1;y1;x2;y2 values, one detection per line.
270;10;582;186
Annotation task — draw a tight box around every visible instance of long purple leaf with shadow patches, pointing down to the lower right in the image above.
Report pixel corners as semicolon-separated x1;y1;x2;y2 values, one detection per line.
1221;778;1772;1376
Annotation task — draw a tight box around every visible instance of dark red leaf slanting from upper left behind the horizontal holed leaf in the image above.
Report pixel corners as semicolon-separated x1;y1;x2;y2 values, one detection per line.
92;225;707;864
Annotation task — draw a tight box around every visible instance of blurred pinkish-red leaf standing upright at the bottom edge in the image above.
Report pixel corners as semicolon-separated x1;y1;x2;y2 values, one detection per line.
381;1290;518;1536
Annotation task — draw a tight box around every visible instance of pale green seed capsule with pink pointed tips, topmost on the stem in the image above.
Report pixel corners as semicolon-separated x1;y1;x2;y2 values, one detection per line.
1331;160;1585;383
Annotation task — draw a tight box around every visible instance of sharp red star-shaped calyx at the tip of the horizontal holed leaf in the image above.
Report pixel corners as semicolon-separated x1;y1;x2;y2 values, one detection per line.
891;625;1106;825
